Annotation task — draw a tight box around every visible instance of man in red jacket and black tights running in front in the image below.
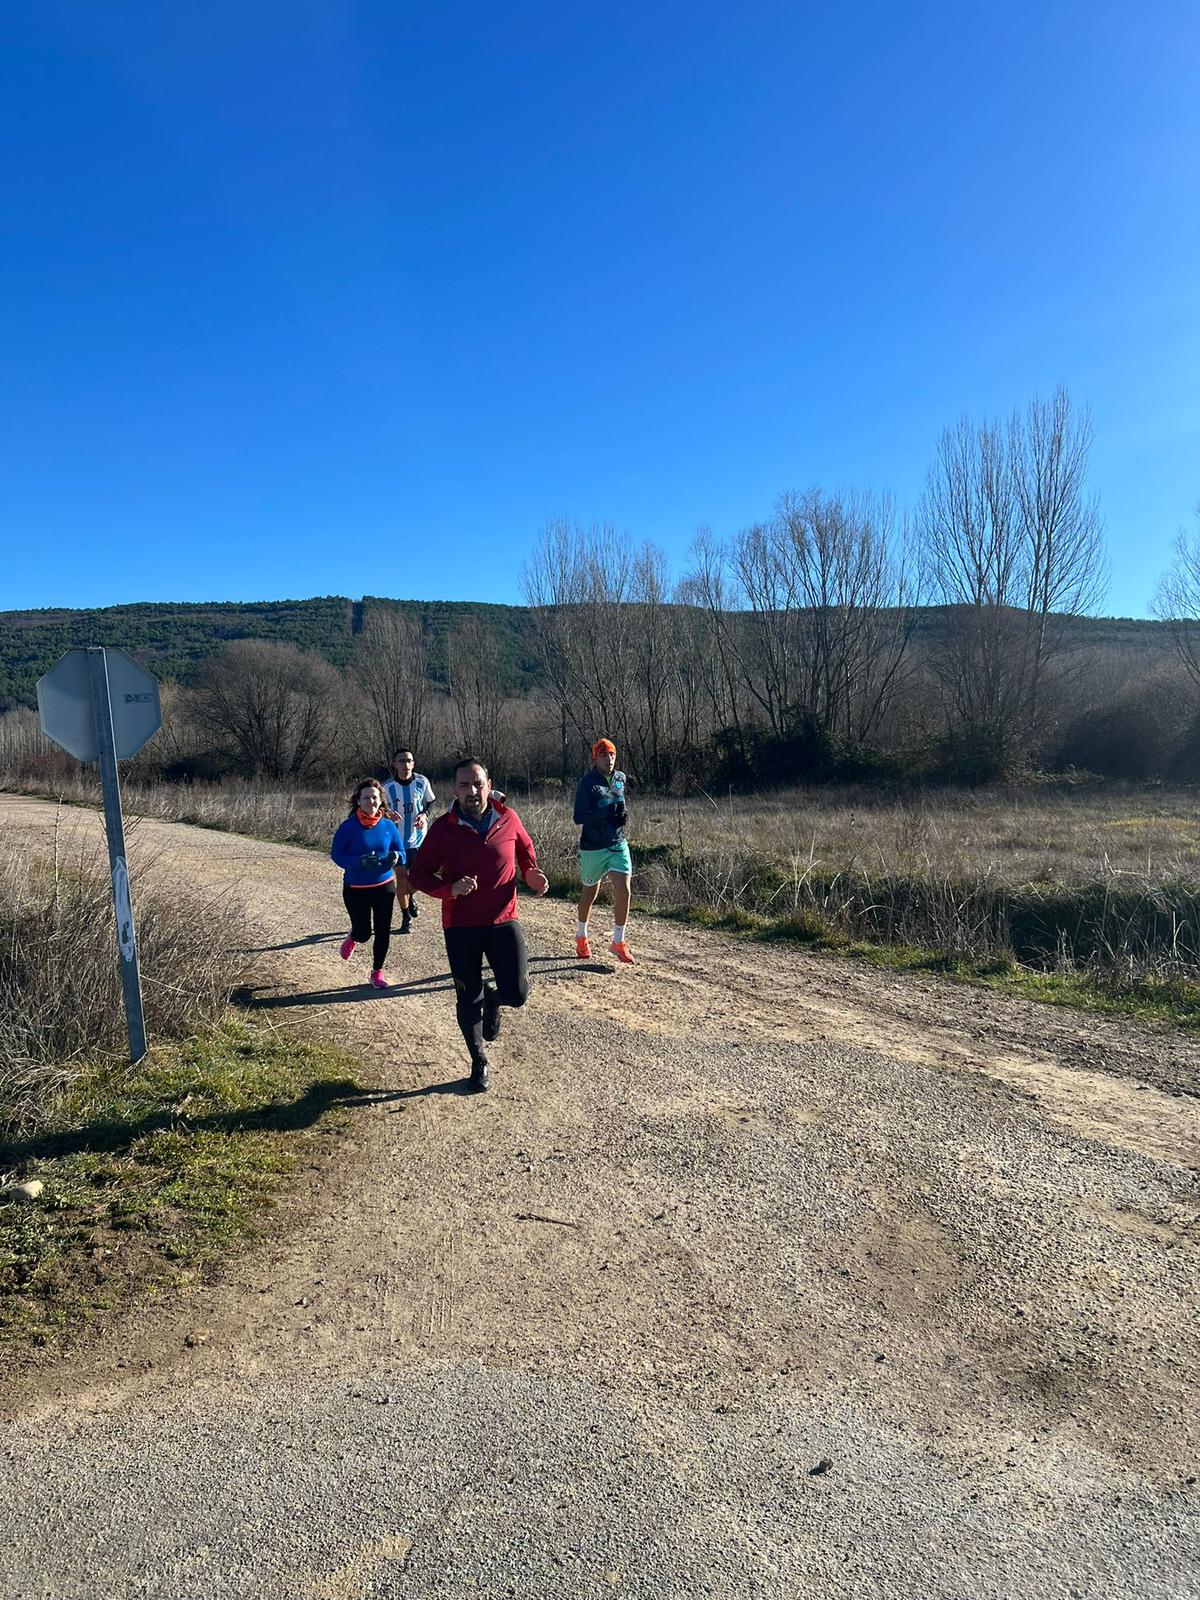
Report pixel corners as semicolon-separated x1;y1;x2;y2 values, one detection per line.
410;755;550;1090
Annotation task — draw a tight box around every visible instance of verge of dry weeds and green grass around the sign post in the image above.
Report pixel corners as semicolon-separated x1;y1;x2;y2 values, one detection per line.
0;825;360;1368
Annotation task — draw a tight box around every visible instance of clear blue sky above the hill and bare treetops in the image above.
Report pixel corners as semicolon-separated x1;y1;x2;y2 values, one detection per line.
0;0;1200;614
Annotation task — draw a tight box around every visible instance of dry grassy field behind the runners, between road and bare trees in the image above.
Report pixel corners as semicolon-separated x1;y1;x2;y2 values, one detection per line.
9;782;1200;1010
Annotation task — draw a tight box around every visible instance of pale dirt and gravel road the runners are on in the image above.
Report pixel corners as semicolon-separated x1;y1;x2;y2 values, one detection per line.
0;797;1200;1600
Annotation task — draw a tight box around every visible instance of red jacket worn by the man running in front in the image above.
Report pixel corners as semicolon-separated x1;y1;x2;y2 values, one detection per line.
408;800;538;928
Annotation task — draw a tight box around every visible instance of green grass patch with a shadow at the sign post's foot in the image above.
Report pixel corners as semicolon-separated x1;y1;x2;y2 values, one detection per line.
0;1018;363;1349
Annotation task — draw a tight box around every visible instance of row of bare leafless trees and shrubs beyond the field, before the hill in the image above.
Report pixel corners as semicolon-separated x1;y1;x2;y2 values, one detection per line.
0;389;1200;789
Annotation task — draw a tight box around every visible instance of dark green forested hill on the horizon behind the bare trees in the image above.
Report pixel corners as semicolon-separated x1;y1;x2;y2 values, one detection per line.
0;595;1166;710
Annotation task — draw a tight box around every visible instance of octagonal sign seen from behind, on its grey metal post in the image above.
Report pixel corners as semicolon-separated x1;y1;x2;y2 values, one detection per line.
37;646;162;1066
